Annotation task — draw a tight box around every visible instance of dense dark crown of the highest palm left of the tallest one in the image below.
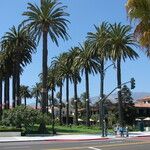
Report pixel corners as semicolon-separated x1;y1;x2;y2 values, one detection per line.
1;25;36;66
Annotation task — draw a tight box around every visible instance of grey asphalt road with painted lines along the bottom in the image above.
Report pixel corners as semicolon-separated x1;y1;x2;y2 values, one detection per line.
0;138;150;150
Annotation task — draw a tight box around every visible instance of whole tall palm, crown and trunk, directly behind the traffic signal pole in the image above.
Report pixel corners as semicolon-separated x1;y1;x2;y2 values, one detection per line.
87;22;109;136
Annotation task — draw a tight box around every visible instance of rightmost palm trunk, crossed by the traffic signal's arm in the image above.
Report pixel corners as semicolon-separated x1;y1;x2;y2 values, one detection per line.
117;58;123;127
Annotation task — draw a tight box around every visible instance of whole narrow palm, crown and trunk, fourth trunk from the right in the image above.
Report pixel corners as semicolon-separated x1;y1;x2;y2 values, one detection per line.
69;47;81;125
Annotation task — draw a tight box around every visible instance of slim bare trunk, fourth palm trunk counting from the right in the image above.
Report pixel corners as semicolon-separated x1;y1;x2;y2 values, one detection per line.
74;77;78;125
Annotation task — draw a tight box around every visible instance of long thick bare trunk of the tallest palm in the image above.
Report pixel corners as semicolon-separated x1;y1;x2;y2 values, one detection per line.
42;30;48;113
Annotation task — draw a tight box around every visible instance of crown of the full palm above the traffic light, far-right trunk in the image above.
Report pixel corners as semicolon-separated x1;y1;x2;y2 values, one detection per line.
108;23;138;61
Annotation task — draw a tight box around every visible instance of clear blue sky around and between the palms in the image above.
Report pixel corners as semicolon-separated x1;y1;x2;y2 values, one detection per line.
0;0;150;102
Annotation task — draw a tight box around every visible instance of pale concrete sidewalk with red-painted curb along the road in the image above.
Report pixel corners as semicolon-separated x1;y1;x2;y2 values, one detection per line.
0;132;150;143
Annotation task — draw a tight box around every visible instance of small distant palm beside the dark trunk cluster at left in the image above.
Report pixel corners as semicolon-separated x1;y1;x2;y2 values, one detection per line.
20;85;31;107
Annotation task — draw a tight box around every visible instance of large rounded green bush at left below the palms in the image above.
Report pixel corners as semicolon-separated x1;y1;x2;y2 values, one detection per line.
1;106;50;131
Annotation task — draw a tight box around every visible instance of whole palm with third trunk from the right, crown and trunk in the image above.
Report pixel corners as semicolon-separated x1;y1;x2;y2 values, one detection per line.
74;42;98;126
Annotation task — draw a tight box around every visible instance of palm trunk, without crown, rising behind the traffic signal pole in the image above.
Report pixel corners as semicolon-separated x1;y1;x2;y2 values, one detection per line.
99;60;105;137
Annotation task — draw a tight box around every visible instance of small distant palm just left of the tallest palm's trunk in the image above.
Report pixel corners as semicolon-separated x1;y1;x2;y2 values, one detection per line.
31;83;41;109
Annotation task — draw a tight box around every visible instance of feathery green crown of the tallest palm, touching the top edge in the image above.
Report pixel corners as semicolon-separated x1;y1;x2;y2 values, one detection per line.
23;0;69;45
